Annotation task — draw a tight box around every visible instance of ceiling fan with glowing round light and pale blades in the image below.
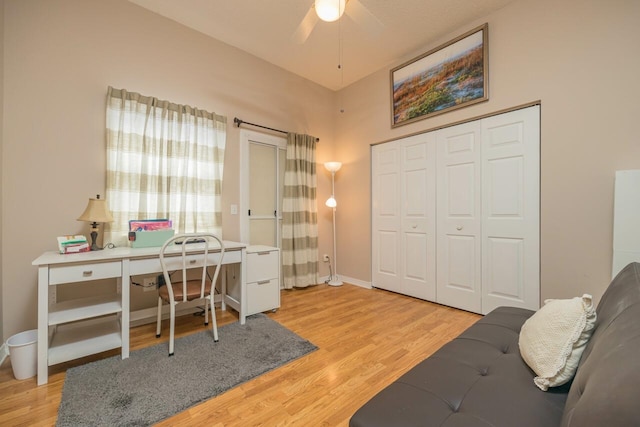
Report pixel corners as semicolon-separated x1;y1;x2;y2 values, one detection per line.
291;0;382;44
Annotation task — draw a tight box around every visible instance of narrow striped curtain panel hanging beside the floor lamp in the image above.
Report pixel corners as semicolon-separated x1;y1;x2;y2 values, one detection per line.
282;133;318;289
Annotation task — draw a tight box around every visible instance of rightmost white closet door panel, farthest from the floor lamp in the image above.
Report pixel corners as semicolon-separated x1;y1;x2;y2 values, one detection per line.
481;106;540;313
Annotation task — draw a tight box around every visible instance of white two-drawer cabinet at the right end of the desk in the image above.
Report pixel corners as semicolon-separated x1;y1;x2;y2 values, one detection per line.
247;245;280;315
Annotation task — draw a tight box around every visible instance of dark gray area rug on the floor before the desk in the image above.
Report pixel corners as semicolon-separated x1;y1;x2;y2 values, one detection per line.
56;314;317;427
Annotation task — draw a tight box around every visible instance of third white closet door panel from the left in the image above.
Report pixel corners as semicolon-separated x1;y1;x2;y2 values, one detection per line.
435;121;482;313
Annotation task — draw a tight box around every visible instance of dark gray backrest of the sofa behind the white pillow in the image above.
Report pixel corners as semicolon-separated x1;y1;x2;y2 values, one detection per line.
562;263;640;427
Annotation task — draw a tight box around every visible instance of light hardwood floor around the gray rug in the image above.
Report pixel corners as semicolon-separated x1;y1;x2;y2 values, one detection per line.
0;284;480;427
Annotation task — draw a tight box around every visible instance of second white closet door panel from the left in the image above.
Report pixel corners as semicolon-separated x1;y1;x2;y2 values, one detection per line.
400;134;436;301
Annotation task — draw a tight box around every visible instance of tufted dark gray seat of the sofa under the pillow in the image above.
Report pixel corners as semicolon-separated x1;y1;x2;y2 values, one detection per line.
349;307;568;427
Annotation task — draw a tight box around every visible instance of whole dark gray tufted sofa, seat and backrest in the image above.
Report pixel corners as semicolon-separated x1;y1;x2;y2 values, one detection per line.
349;263;640;427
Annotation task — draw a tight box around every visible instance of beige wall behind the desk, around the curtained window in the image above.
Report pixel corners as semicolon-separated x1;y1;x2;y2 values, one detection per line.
1;0;335;337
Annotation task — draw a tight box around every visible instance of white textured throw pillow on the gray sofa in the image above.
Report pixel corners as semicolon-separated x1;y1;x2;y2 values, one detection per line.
518;294;596;391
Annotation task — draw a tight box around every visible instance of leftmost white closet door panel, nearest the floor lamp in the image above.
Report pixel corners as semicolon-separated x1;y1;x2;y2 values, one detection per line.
371;142;402;292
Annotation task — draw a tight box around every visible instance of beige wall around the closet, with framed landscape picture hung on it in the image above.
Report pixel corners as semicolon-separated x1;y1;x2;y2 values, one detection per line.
336;0;640;299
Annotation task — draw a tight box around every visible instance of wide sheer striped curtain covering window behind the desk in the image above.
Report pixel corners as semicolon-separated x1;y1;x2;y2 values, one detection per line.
104;87;227;246
